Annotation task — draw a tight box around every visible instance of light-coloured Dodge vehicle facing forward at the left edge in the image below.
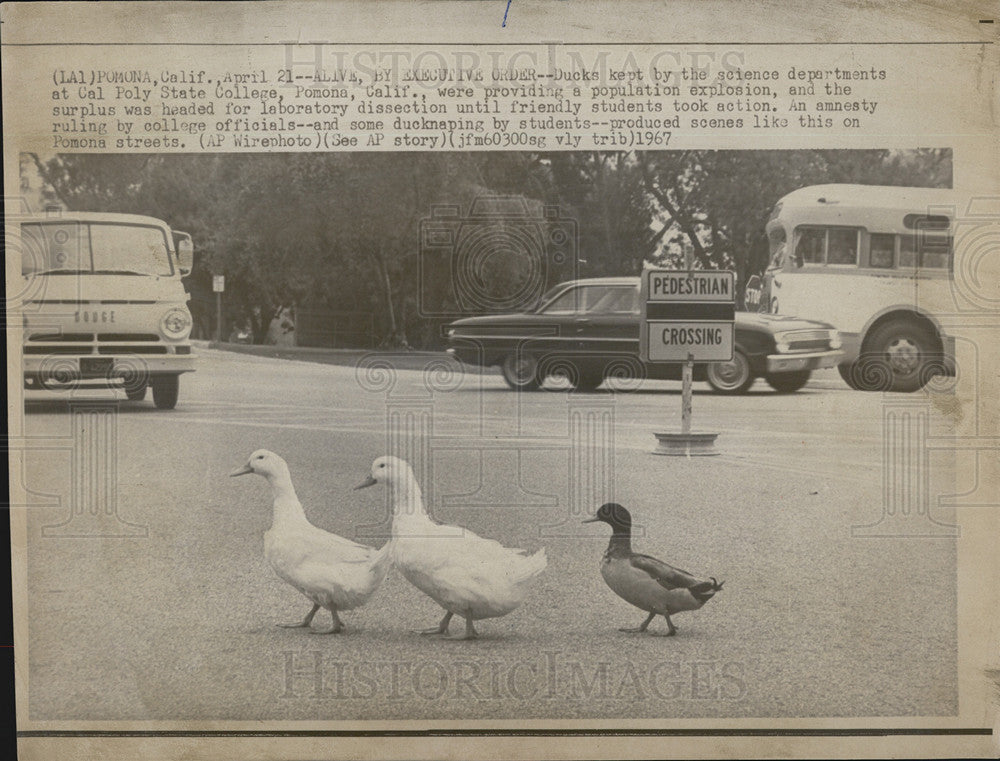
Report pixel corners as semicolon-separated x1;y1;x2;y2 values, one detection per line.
20;212;194;409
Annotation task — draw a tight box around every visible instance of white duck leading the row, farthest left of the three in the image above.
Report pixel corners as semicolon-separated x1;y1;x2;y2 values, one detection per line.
230;449;390;634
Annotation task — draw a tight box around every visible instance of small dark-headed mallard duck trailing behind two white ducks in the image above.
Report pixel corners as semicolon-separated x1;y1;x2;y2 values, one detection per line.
584;502;723;637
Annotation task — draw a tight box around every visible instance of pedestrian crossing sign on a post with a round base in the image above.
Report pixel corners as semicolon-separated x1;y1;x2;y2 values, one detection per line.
639;268;736;457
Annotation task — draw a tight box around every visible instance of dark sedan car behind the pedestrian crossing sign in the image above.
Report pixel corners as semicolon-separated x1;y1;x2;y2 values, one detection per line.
448;277;842;394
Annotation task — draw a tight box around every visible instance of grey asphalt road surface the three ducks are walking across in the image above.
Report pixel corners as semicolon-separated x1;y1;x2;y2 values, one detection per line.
22;349;957;726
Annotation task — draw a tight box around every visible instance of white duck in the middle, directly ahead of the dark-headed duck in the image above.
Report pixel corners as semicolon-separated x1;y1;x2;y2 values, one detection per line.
355;456;546;639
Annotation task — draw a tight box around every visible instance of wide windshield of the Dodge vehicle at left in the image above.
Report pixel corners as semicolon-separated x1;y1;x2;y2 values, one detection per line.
21;220;174;277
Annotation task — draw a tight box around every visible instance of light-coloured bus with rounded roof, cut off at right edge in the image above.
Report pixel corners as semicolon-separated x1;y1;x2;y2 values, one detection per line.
760;184;956;391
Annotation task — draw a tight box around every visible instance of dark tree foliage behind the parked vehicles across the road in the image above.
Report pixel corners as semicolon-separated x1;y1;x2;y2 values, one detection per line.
32;149;951;346
